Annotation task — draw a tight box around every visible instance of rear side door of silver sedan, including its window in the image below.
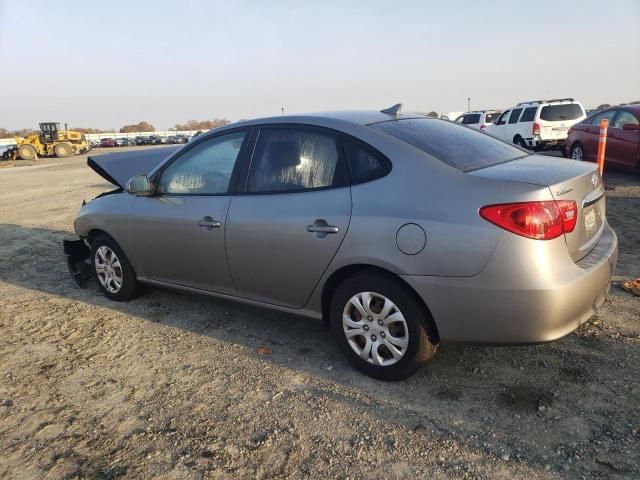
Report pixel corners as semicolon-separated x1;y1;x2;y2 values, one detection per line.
227;125;351;308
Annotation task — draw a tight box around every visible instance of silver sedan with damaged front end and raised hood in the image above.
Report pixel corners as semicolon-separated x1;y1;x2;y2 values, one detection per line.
65;108;617;380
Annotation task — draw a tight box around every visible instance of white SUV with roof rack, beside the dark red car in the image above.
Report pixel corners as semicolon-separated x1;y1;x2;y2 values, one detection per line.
484;98;586;150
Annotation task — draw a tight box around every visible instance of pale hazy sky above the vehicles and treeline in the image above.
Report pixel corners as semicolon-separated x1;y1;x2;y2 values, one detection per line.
0;0;640;129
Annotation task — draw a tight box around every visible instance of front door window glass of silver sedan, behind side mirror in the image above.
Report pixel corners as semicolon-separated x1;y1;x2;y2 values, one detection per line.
158;131;247;195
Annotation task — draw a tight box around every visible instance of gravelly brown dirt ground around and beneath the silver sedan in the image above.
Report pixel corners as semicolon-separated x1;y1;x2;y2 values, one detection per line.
0;148;640;479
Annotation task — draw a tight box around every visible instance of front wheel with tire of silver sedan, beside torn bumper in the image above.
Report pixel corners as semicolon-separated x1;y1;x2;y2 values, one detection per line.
90;234;140;302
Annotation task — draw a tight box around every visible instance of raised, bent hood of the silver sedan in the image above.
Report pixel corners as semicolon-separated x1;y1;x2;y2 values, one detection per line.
87;146;180;188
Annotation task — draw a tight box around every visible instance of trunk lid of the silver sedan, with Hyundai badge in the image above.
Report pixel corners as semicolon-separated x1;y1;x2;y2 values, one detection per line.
469;155;605;261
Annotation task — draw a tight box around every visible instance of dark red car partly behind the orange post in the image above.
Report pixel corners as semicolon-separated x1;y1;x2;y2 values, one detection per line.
564;104;640;173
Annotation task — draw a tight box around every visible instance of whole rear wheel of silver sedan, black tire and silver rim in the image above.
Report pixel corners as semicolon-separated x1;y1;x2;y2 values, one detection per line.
330;270;438;380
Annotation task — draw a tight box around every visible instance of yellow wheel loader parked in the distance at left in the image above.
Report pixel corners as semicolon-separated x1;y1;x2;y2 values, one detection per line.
3;122;90;160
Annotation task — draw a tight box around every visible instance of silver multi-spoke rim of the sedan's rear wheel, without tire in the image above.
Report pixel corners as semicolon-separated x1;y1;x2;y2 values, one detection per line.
342;292;409;367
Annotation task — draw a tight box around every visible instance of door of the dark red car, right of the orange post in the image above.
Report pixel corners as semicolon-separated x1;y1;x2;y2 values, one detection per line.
605;110;640;170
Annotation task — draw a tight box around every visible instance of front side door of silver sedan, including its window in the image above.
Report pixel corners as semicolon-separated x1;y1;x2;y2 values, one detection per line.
130;129;249;295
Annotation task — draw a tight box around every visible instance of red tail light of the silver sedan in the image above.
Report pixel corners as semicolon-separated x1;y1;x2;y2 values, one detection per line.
480;200;578;240
